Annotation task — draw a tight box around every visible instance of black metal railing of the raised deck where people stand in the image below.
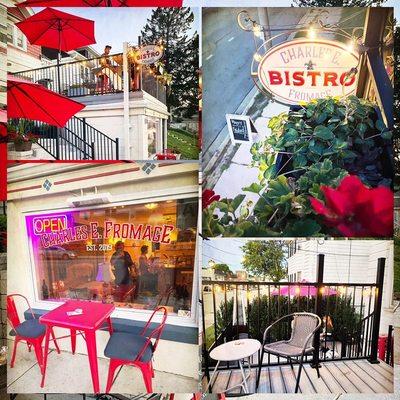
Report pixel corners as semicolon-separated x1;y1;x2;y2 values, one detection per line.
14;53;166;104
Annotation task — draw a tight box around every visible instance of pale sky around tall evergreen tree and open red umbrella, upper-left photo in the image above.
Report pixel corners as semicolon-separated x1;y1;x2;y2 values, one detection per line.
33;7;200;53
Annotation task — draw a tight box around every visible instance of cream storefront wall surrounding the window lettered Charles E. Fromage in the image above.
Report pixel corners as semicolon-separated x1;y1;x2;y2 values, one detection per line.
7;163;199;378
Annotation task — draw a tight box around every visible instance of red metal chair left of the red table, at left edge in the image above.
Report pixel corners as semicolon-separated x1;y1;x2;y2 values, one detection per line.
7;294;60;373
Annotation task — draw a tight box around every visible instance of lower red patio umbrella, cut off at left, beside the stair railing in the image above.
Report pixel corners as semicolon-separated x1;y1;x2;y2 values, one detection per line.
7;75;85;128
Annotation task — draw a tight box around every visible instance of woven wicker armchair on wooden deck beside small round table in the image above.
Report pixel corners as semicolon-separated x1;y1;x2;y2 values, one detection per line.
257;312;321;393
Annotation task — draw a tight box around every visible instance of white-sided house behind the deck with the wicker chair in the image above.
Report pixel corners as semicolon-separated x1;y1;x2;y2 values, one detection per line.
288;238;398;333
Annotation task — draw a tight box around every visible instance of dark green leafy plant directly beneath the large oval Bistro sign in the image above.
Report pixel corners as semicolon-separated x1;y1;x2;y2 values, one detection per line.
252;96;393;187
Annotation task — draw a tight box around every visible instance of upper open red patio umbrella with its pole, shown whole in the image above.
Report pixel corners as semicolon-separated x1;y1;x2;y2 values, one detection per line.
16;8;96;90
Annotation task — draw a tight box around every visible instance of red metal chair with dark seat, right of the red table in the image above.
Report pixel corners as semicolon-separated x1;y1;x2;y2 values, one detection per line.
104;307;168;393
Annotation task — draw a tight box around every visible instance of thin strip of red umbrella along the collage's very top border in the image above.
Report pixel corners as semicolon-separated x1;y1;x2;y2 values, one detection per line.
17;0;183;7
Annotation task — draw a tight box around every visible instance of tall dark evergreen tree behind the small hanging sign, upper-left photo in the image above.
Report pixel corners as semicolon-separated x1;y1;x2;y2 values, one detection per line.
141;7;199;117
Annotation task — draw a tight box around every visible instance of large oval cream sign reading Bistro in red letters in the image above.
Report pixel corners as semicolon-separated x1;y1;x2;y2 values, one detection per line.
258;38;358;104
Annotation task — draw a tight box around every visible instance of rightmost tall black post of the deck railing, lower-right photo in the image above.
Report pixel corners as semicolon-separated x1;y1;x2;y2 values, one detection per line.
368;258;385;364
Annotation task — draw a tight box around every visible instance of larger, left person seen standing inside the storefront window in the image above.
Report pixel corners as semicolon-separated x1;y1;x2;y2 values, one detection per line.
110;241;136;302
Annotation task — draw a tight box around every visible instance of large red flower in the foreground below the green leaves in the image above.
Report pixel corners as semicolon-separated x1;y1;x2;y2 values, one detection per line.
310;176;394;237
